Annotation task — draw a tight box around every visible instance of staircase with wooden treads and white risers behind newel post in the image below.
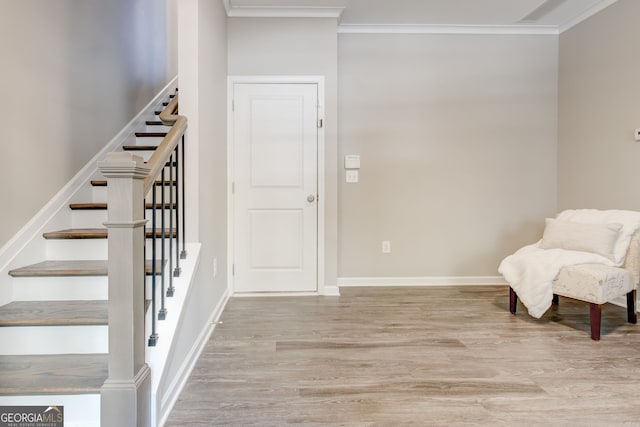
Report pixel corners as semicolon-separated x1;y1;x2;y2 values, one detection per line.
0;96;179;427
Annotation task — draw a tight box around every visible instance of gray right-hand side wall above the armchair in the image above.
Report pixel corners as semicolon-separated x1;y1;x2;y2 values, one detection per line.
558;0;640;210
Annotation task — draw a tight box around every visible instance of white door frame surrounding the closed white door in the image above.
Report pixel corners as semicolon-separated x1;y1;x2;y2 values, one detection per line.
227;76;325;296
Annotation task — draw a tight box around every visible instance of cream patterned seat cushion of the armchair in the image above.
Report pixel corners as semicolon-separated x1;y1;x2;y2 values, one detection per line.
553;264;635;304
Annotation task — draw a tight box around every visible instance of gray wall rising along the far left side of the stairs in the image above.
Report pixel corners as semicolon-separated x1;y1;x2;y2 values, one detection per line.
0;0;176;247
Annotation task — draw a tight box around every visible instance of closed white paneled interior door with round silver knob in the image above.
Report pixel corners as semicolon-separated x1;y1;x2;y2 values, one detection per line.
233;83;318;292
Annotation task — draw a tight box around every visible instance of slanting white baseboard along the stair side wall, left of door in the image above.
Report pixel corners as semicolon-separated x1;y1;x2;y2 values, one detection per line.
156;289;230;427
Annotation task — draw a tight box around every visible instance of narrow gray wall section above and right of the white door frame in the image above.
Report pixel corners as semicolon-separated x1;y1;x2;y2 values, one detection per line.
228;18;338;286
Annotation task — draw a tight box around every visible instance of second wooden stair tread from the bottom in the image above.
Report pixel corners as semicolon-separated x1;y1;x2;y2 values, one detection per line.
0;301;108;327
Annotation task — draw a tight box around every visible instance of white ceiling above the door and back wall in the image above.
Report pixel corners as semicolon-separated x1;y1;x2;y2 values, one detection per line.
223;0;617;33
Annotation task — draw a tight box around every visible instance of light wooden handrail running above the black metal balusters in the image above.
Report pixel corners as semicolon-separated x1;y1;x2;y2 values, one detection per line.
144;94;187;194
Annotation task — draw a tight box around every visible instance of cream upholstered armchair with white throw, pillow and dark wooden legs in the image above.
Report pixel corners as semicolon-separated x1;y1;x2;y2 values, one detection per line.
499;209;640;340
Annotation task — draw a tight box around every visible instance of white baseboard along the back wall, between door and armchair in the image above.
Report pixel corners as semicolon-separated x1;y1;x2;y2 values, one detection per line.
338;276;507;287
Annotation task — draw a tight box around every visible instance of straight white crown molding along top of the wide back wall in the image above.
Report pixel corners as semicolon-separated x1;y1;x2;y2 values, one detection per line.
338;25;559;36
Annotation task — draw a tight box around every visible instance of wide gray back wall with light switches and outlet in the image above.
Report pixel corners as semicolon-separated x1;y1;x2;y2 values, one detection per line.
338;34;558;277
